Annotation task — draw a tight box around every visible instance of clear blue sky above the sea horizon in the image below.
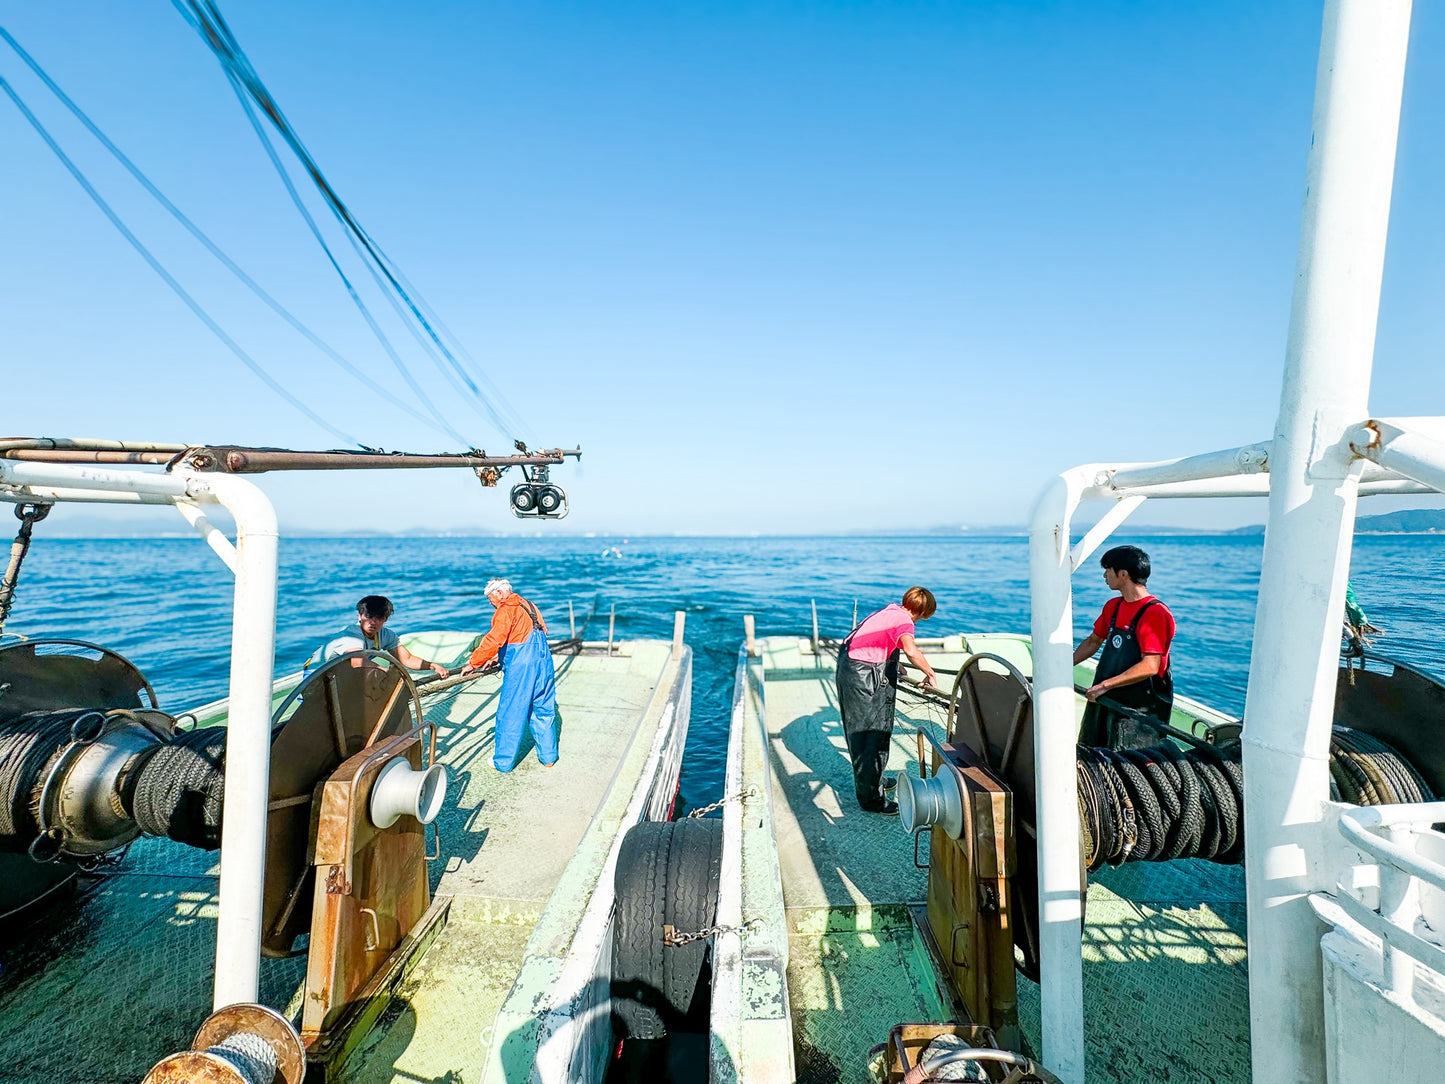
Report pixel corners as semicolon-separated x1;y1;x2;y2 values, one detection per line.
0;0;1445;532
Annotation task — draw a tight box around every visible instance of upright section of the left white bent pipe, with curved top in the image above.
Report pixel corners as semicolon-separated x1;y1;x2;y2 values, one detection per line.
191;474;276;1009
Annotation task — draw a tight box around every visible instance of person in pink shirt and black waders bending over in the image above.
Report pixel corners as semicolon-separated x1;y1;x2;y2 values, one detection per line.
838;587;938;815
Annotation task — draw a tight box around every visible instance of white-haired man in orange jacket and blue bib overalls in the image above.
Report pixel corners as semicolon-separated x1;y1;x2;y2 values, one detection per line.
461;578;558;772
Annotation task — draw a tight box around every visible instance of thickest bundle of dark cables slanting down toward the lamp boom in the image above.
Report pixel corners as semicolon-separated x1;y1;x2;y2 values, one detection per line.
172;0;517;435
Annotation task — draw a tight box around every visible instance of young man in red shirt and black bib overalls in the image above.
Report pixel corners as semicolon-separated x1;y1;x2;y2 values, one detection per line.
1074;546;1175;749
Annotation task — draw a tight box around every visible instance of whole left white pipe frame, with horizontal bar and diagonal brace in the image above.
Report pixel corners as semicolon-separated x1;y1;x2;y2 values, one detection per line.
0;460;277;1009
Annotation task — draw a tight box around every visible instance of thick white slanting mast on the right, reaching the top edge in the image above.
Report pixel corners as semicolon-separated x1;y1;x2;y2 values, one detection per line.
1244;0;1410;1084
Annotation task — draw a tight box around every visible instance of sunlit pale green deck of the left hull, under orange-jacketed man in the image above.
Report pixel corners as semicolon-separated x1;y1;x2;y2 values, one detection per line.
0;635;691;1084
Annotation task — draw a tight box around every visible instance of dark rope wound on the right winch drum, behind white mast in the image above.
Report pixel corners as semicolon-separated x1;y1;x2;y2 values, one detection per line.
1077;727;1433;872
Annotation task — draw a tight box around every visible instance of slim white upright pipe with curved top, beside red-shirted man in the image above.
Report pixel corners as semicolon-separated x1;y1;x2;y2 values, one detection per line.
1029;467;1097;1084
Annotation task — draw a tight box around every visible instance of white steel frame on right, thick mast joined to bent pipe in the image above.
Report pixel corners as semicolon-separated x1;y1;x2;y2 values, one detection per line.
1030;0;1416;1084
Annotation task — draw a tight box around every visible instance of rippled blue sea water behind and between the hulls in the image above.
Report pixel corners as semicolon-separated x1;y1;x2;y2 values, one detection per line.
7;525;1445;806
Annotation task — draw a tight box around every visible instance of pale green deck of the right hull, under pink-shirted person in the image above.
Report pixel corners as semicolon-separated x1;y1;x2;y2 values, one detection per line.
740;636;1248;1084
